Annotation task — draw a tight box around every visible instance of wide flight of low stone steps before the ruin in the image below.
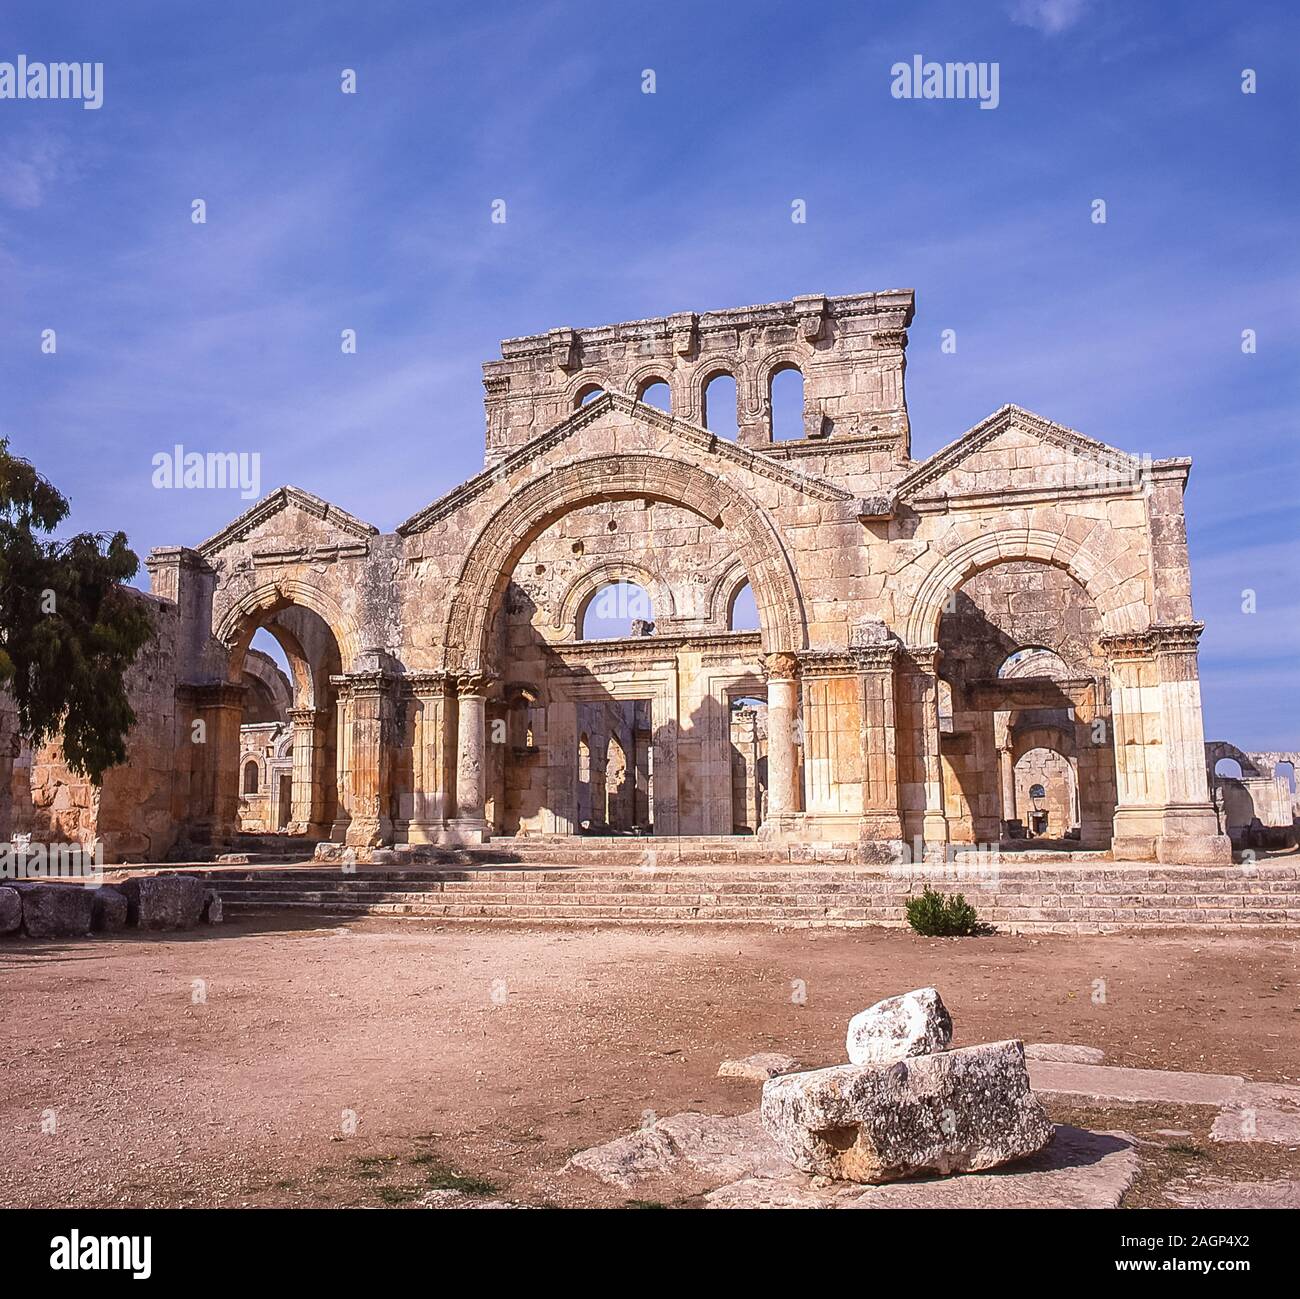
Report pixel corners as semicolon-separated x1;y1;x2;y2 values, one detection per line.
129;849;1300;932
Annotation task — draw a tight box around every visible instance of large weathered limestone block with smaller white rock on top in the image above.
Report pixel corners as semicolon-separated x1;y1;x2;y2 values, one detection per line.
761;1042;1053;1183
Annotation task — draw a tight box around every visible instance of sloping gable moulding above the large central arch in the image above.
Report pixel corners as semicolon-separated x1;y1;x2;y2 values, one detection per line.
398;393;857;536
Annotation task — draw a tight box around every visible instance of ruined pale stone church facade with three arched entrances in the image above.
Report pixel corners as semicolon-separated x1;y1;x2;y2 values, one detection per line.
0;290;1268;863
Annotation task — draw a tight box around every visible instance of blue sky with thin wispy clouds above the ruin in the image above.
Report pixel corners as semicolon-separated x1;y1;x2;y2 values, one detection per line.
0;0;1300;748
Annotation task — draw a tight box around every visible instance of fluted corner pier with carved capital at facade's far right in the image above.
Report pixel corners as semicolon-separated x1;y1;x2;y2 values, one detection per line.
1102;623;1231;865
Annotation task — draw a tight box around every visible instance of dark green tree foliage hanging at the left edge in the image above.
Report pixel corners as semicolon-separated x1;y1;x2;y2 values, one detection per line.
0;438;153;784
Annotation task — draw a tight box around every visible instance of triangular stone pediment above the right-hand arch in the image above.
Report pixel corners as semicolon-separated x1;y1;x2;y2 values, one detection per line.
896;406;1141;502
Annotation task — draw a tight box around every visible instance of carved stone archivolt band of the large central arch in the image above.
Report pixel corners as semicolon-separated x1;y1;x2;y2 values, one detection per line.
443;453;806;672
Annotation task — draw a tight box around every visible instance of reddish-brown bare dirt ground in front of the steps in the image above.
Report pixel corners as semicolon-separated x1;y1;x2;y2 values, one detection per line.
0;919;1300;1205
